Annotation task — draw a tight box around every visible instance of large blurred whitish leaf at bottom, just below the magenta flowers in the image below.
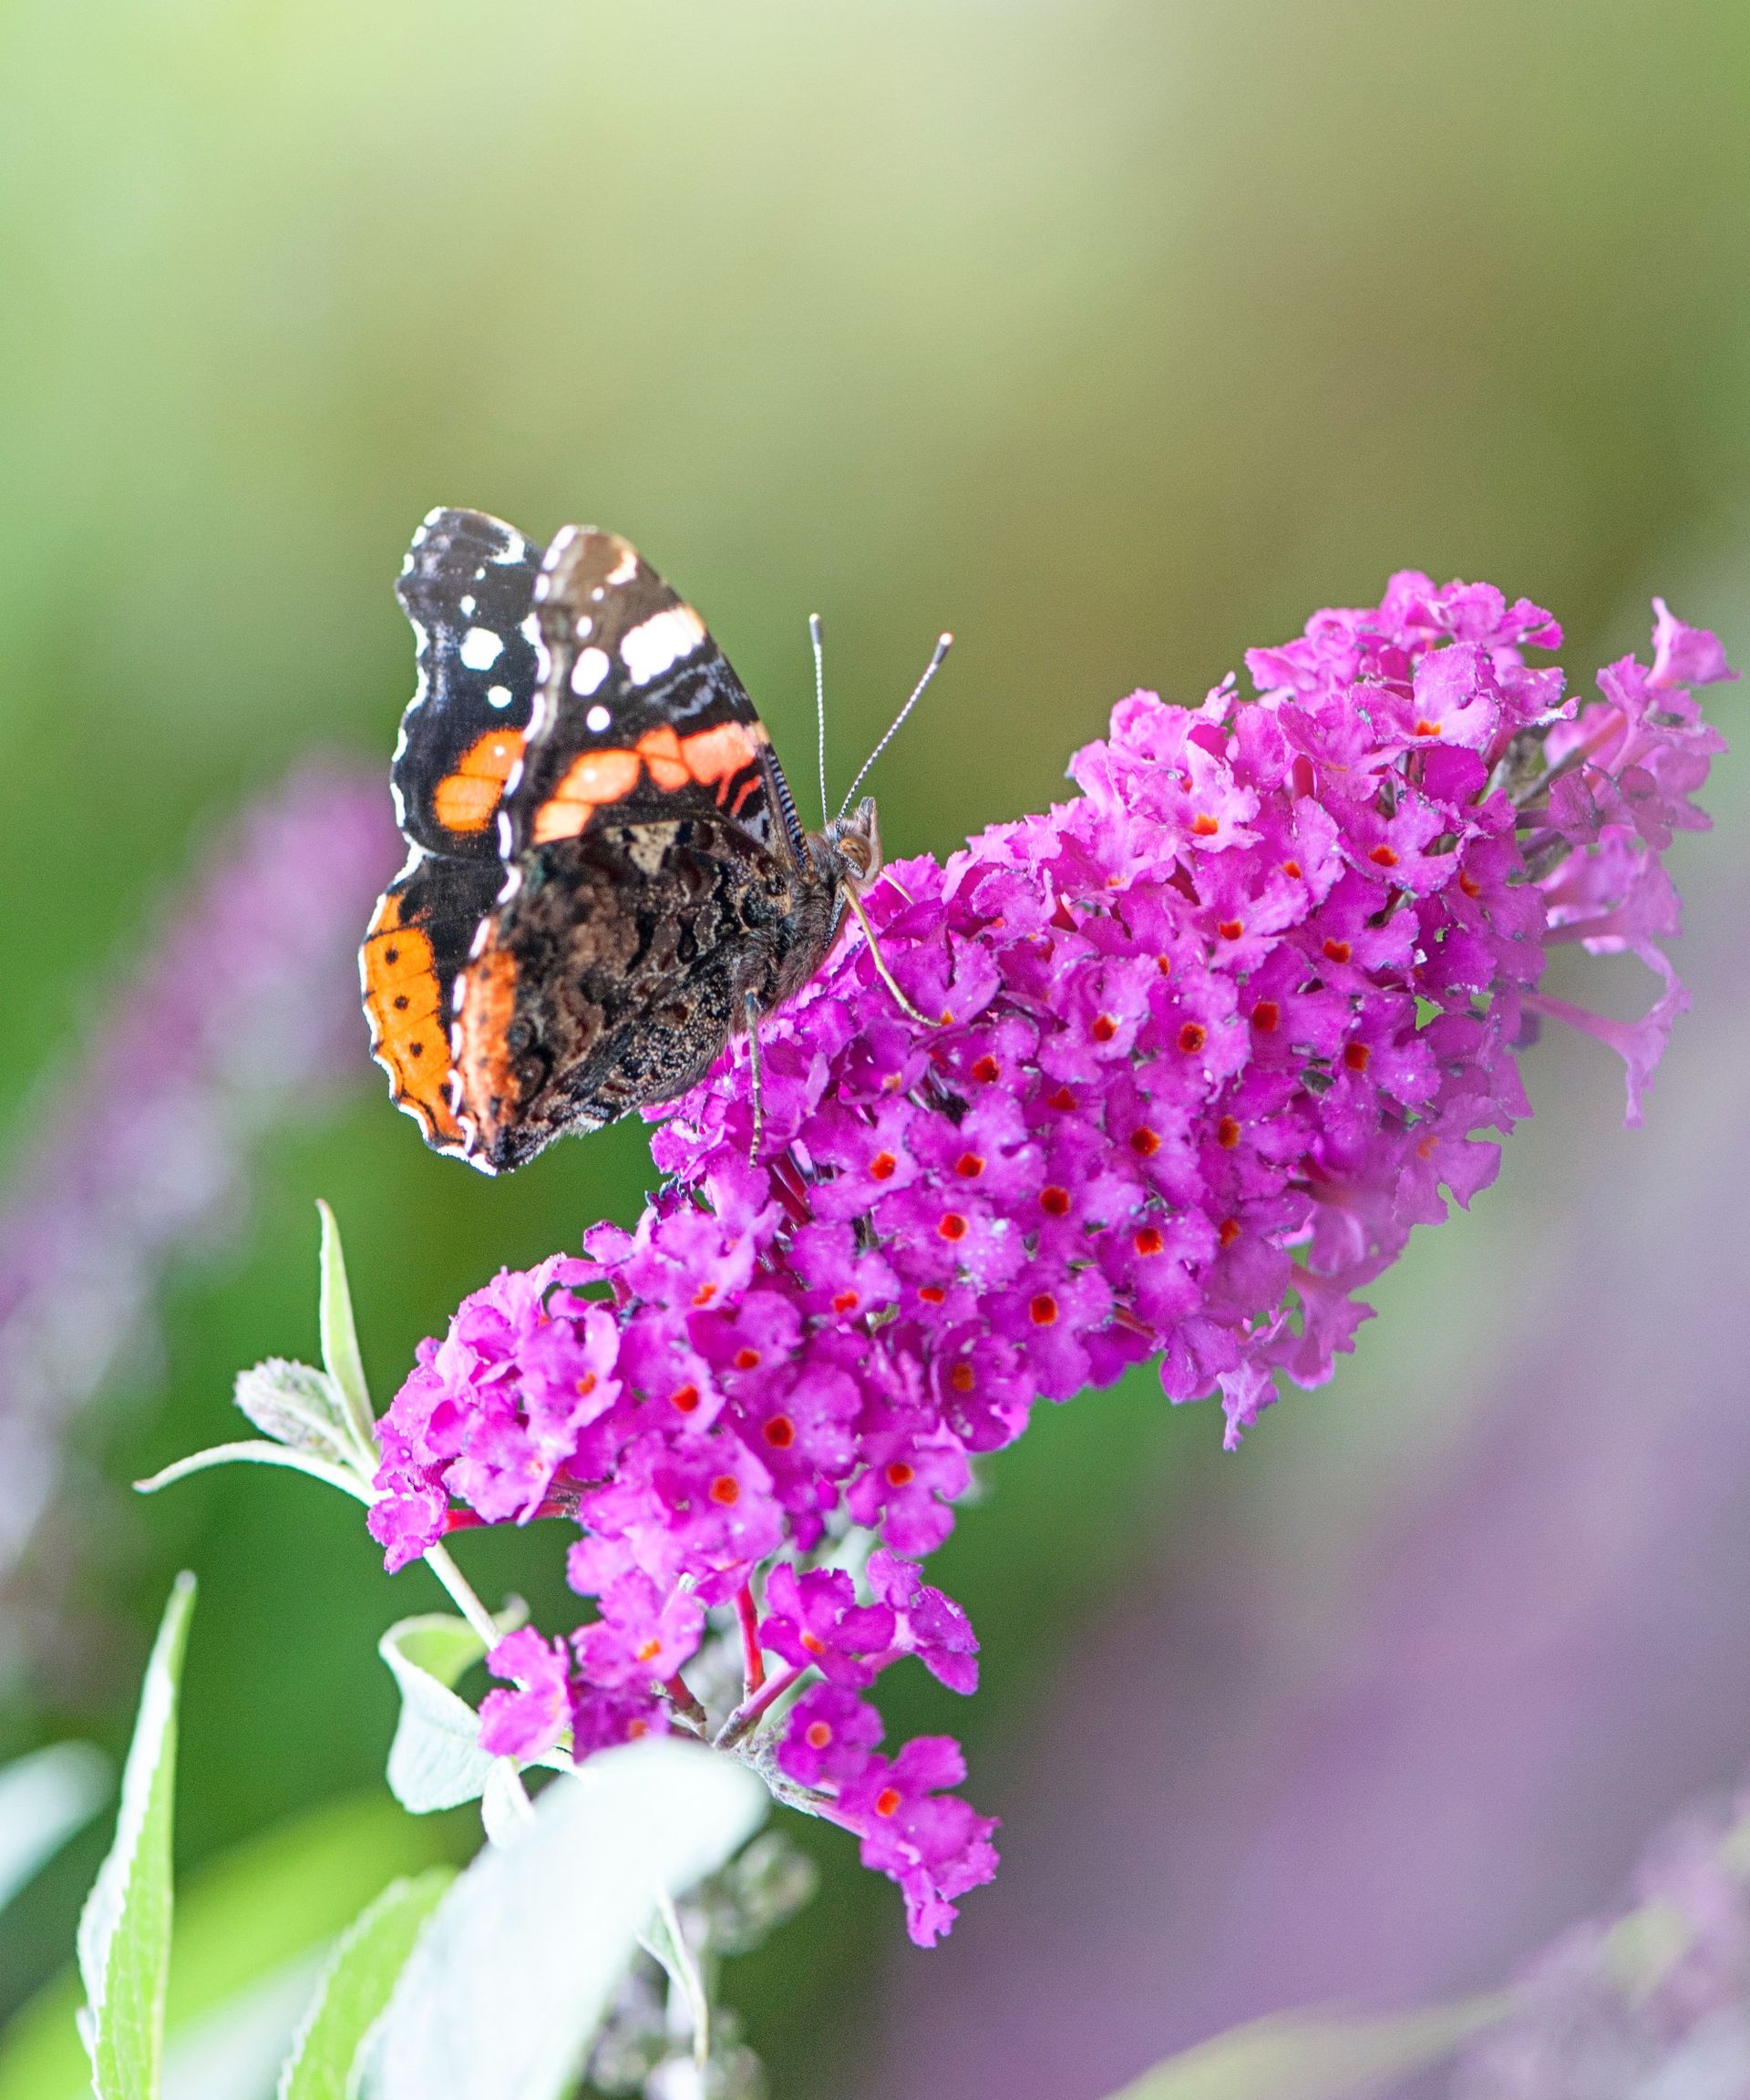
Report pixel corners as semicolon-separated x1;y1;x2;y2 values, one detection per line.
364;1739;769;2100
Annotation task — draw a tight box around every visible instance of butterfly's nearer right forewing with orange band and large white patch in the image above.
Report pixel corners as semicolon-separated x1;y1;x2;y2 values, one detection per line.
500;525;802;868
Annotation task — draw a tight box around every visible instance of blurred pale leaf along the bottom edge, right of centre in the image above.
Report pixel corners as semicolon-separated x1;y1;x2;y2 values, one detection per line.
1111;1992;1510;2100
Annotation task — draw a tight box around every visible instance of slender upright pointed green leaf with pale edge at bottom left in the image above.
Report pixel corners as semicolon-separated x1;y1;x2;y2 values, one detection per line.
77;1573;195;2100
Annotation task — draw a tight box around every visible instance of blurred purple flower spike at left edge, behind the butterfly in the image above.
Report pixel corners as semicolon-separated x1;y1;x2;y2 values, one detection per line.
0;765;397;1680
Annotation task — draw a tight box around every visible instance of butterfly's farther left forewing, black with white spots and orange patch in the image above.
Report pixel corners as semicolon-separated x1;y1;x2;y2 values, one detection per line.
388;510;542;861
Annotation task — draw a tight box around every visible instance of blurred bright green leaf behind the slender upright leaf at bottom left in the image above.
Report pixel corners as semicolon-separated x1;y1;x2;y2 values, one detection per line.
0;1787;467;2100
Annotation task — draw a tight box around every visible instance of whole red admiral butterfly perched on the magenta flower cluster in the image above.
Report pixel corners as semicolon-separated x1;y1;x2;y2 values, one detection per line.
359;510;948;1174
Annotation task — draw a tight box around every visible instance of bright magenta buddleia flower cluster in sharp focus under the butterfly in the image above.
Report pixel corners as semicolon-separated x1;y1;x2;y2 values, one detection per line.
372;573;1731;1945
